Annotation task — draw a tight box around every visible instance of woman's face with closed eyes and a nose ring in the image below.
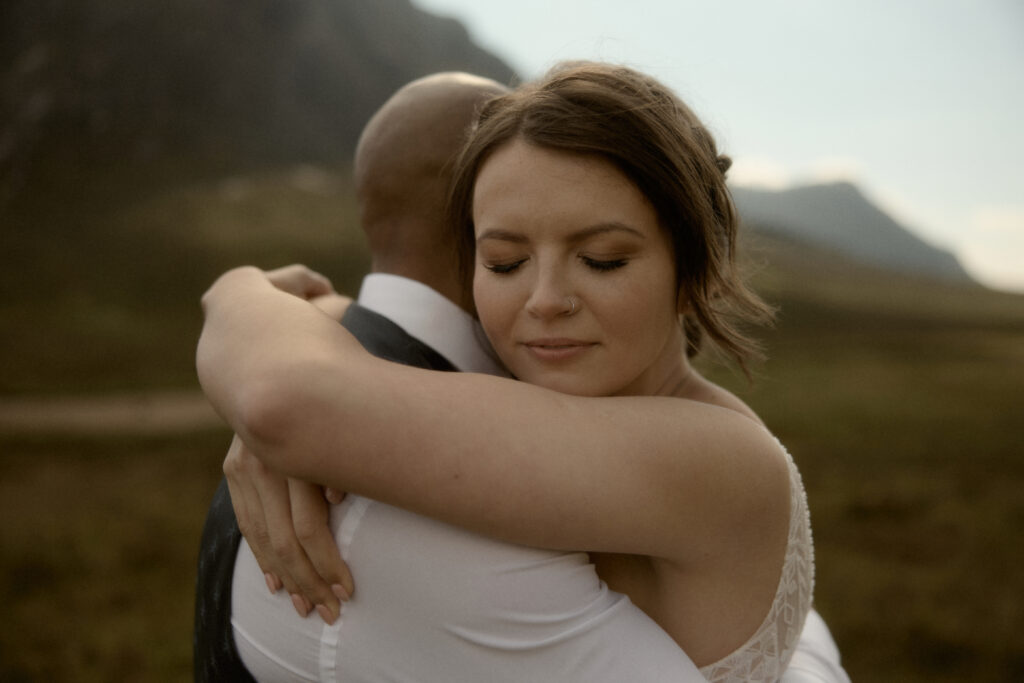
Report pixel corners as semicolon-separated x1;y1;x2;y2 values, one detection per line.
473;140;685;396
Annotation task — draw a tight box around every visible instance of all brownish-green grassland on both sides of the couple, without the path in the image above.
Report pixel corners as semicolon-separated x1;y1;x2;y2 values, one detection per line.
0;169;1024;682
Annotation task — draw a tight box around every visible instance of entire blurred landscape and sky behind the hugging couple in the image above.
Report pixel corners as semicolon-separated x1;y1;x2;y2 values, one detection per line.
0;0;1024;681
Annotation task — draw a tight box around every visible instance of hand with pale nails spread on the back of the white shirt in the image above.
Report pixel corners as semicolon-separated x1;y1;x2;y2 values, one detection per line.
224;436;353;624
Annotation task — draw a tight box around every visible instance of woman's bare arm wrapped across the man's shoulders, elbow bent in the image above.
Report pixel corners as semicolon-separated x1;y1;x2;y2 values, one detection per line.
197;268;788;563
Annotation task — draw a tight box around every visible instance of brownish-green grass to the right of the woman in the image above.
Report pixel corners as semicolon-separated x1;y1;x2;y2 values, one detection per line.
700;242;1024;681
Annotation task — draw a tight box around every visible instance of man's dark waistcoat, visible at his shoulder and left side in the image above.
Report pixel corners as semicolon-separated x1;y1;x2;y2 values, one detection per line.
193;304;455;683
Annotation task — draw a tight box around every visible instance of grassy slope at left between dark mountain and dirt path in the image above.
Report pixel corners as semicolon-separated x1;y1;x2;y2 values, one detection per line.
0;161;369;395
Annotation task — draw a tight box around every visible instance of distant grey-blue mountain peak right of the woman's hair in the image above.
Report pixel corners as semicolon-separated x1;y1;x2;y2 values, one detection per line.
732;182;973;283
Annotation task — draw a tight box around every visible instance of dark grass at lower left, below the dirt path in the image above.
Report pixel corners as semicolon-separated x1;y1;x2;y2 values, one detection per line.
0;432;227;683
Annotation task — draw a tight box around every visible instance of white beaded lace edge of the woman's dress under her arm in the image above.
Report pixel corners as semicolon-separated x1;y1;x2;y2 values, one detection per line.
700;447;814;683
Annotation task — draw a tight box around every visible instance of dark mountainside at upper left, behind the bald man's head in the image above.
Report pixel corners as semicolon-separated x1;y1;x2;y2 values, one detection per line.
0;0;515;199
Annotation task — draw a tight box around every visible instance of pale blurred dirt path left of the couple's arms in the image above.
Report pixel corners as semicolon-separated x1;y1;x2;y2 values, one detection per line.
0;391;223;435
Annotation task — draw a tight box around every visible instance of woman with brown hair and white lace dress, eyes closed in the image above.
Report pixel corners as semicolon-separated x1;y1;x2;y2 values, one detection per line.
198;63;812;680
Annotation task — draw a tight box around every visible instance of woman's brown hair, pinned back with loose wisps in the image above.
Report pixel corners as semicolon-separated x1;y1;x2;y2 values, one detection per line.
449;62;772;370
